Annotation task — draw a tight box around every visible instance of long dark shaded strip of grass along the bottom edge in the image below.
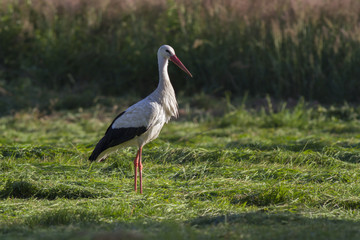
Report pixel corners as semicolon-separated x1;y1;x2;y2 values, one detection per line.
9;210;360;240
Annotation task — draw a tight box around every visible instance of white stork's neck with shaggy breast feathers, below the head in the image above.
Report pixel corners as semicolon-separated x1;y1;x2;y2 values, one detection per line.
154;55;178;117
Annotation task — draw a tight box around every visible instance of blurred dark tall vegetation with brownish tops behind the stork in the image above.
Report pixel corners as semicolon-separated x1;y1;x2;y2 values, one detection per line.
0;0;360;115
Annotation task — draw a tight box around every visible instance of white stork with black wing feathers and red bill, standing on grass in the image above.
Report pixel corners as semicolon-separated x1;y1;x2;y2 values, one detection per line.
89;45;192;193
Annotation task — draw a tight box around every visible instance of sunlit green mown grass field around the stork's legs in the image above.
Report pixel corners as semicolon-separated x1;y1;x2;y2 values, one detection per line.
0;101;360;239
